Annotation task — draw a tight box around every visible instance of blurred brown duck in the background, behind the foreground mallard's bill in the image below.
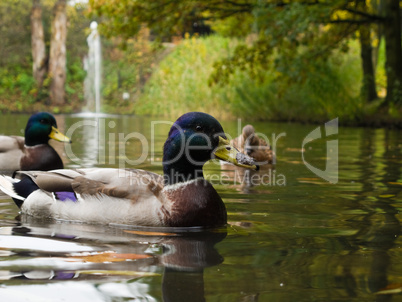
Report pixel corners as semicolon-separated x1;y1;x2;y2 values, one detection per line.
230;125;276;165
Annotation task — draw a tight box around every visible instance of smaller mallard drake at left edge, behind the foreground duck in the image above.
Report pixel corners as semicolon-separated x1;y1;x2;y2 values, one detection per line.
0;112;71;171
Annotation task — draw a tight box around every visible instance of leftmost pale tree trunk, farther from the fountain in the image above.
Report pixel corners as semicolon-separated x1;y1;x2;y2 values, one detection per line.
31;0;46;88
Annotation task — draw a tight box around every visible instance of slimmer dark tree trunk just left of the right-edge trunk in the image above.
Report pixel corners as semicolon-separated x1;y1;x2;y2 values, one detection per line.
359;24;377;102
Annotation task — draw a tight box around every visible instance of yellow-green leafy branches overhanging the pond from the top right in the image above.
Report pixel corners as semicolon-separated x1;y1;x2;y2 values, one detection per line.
90;0;357;94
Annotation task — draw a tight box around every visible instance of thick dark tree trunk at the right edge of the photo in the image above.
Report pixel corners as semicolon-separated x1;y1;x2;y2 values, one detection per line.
384;0;402;105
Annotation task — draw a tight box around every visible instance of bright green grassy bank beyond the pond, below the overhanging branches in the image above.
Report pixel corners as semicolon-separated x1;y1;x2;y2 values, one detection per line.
134;36;399;125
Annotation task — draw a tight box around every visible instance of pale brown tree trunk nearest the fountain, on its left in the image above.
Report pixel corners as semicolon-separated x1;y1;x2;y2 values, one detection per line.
49;0;67;105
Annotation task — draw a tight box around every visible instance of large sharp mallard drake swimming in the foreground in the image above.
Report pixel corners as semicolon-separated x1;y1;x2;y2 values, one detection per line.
0;112;258;227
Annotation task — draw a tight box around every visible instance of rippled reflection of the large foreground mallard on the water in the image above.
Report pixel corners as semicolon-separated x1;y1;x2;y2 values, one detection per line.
0;215;226;301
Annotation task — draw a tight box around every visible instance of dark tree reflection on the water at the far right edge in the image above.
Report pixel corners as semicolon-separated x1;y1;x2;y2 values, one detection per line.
356;129;401;301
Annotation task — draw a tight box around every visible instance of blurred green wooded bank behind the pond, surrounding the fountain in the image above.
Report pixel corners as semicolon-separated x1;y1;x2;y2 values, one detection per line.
0;0;402;126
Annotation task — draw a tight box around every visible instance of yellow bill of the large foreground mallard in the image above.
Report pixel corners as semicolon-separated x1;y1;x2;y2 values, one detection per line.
214;136;259;170
